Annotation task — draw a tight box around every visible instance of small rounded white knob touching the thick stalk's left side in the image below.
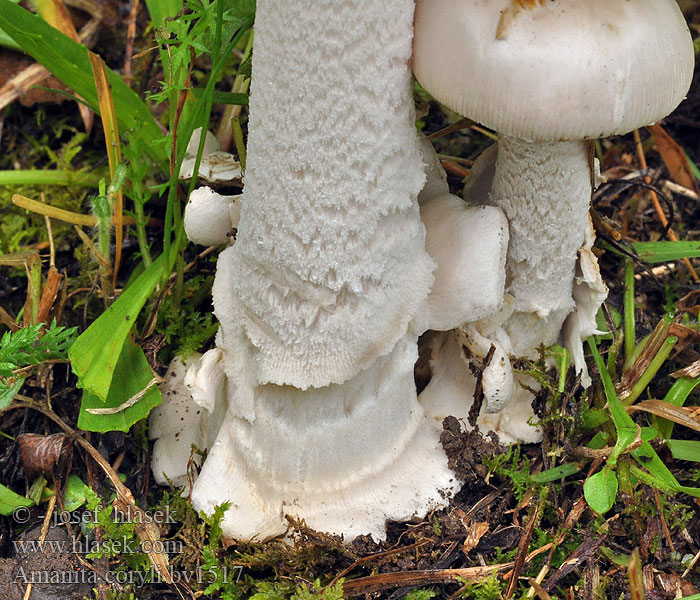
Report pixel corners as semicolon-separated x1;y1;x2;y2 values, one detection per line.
184;186;240;246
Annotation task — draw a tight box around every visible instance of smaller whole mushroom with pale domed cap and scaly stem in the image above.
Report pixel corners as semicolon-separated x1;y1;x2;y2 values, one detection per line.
413;0;693;373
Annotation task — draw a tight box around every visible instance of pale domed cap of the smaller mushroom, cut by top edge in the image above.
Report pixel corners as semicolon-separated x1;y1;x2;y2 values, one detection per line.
413;0;694;141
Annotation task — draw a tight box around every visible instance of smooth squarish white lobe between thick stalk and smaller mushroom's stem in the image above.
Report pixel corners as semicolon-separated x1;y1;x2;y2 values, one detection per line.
420;194;508;331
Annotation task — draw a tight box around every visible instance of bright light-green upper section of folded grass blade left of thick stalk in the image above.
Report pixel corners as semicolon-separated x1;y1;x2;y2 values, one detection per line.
69;250;175;402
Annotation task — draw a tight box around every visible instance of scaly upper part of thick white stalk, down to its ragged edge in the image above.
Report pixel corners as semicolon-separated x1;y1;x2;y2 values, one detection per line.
224;0;433;389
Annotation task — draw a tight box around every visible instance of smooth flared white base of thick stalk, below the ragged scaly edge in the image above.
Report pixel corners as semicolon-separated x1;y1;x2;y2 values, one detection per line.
192;335;459;540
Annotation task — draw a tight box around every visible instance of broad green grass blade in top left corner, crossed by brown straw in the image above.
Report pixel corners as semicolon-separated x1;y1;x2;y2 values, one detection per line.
0;0;167;166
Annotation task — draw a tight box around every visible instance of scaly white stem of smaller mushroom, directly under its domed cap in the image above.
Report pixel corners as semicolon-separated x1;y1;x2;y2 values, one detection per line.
491;135;592;355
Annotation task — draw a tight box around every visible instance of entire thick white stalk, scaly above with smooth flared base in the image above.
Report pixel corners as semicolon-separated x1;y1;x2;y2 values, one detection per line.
180;0;507;539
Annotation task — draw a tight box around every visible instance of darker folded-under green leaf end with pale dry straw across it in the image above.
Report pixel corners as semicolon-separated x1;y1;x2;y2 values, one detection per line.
78;340;162;433
